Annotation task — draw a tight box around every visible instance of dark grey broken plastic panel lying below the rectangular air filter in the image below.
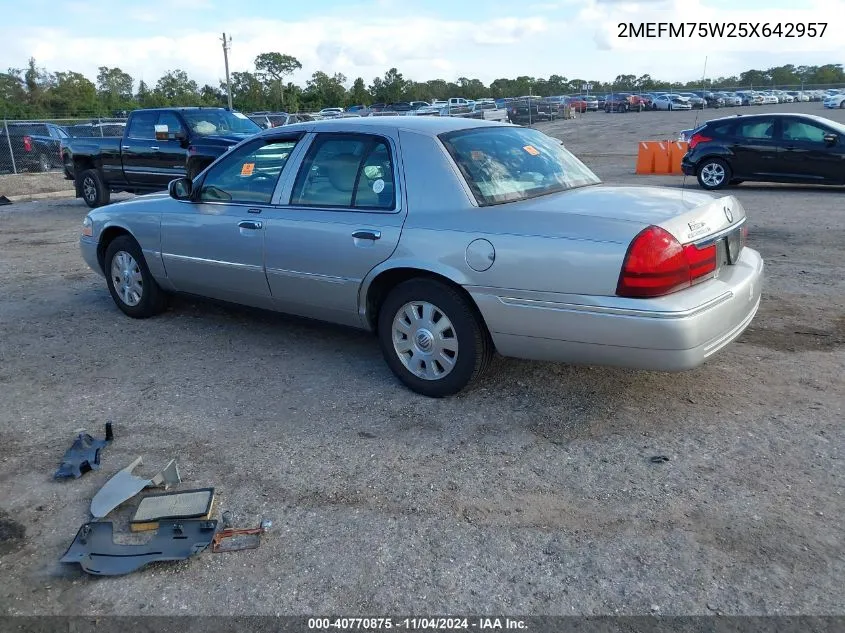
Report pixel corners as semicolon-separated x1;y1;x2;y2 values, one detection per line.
60;520;217;576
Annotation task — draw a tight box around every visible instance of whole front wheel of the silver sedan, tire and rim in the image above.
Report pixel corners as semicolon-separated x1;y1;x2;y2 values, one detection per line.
103;235;167;319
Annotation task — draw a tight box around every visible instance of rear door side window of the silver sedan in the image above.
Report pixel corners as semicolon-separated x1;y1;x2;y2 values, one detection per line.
290;134;396;211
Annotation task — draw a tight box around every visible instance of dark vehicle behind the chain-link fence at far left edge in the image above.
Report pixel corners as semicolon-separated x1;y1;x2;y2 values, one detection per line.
0;121;69;171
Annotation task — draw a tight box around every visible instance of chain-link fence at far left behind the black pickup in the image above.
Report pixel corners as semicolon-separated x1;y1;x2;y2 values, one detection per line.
0;117;126;174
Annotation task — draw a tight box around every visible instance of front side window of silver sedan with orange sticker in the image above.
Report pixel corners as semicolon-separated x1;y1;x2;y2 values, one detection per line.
199;139;297;204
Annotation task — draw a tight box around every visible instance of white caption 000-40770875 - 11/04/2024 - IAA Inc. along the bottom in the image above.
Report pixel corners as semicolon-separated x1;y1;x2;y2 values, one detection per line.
308;617;527;631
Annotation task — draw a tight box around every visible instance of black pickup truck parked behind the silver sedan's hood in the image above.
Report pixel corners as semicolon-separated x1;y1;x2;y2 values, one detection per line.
62;108;261;208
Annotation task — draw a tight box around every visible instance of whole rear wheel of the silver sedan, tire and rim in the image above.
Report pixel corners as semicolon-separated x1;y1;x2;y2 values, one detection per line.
378;279;494;398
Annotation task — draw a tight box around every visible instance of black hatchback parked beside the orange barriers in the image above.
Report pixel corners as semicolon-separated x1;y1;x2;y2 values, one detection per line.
681;114;845;190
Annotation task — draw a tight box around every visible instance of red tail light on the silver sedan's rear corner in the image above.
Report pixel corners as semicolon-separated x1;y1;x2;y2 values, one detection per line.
616;226;717;298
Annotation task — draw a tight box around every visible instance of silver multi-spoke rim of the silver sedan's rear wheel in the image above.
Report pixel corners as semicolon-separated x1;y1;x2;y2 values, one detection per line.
392;301;458;380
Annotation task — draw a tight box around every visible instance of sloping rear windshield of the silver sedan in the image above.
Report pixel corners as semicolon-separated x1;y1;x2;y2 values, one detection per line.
440;126;601;206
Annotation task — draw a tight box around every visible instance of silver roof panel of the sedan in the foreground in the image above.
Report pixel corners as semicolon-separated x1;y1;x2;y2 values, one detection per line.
260;116;515;136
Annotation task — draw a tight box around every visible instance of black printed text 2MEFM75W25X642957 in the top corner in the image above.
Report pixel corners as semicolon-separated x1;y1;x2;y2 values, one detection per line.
616;22;828;39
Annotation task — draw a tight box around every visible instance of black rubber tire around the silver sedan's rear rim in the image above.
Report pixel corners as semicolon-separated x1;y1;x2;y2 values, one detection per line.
378;278;495;398
